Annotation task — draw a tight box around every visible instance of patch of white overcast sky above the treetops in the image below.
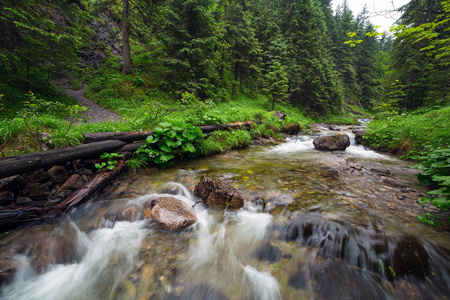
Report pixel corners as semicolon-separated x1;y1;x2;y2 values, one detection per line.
333;0;409;32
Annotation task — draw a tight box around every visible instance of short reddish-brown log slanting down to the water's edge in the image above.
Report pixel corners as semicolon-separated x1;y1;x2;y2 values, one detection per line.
58;160;126;213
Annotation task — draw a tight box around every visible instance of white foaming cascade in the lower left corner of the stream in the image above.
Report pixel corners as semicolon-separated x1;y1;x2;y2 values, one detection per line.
1;222;149;300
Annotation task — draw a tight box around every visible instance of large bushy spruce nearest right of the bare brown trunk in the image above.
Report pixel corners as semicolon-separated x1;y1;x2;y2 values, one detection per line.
162;0;222;99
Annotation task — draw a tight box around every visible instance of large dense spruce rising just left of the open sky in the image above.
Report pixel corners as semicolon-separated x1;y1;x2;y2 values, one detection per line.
281;0;342;114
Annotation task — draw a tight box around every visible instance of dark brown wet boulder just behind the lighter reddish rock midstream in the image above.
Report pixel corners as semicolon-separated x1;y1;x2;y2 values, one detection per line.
194;175;244;209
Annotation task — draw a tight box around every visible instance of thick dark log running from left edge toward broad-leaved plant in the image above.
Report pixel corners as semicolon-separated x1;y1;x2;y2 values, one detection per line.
0;140;127;178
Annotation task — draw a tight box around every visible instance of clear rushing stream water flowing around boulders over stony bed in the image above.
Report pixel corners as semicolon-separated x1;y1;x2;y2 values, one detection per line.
0;123;450;300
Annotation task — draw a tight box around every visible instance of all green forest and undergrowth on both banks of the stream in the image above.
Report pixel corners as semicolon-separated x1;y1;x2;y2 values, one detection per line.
0;0;450;223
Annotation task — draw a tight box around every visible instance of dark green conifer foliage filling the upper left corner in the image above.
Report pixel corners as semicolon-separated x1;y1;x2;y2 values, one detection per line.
0;0;89;90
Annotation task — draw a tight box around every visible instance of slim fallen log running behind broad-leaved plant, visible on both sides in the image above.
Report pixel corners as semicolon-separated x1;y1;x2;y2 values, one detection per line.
83;121;262;144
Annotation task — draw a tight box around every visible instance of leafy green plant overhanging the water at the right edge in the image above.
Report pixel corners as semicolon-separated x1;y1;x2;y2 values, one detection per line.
411;148;450;226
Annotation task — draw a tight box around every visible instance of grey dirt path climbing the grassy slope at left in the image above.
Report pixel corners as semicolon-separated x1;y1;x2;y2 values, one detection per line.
62;86;121;123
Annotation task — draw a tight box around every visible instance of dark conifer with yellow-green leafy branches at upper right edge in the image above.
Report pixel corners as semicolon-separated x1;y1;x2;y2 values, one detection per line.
390;1;450;109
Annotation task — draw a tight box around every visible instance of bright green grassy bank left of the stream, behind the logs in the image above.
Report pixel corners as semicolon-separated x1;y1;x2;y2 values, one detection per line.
0;75;313;156
